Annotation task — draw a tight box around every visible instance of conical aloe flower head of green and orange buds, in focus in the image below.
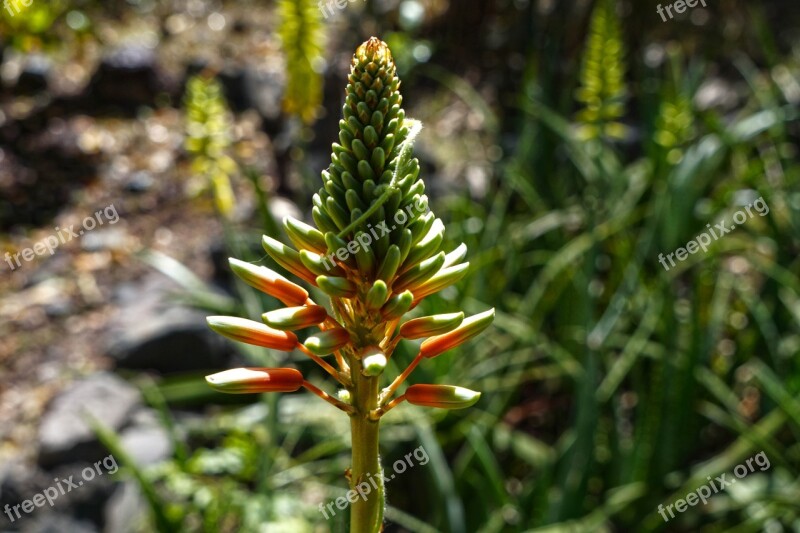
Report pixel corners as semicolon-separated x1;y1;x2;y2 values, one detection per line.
203;37;494;420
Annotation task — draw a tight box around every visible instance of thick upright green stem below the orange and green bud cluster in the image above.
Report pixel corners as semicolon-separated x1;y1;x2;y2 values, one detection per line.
350;361;384;533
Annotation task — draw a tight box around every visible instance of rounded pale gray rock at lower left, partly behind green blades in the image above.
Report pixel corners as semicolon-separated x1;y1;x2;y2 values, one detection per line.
39;372;141;467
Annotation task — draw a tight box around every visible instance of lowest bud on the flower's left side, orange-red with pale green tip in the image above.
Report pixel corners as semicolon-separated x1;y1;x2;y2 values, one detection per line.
206;368;303;394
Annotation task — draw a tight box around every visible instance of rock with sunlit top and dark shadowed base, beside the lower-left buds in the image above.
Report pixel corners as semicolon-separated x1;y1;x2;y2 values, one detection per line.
106;274;229;373
